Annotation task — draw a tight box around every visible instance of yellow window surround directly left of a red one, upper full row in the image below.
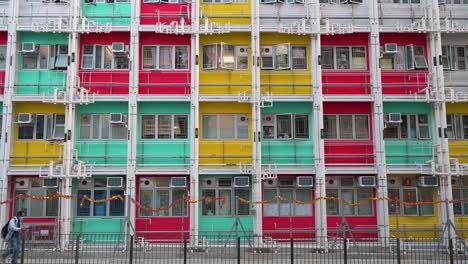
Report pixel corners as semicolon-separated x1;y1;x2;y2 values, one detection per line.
260;33;312;95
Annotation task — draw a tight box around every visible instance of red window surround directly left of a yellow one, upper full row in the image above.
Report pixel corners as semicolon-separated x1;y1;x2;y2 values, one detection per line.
139;32;190;95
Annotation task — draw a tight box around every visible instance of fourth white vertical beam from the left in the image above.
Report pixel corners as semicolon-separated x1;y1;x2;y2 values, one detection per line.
189;1;201;244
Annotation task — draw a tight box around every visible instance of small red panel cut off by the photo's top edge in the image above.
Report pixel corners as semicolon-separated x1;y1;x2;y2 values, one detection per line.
140;0;191;25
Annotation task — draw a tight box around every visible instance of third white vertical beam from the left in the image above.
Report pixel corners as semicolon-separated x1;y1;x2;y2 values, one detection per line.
126;0;140;234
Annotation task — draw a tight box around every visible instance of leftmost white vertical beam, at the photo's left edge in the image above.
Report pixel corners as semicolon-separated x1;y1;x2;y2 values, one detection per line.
0;1;20;227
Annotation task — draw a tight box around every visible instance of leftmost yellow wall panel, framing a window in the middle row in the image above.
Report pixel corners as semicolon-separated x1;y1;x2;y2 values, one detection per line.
11;102;65;167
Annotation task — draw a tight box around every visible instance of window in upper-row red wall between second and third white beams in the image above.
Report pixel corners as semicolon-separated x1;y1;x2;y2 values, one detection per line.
81;45;128;70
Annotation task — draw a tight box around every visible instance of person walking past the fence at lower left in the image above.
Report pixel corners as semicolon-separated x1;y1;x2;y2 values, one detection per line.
0;211;25;264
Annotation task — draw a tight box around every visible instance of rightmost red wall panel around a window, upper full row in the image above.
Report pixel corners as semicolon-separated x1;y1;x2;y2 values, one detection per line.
380;33;430;95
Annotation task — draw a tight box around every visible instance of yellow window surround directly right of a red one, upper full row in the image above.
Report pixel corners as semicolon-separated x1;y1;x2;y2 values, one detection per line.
200;33;252;95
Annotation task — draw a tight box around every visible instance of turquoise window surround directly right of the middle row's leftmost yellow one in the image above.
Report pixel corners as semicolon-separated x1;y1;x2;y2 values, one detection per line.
76;102;128;166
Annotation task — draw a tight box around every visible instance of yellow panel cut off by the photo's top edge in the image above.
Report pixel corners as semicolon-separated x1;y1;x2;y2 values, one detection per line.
200;0;251;25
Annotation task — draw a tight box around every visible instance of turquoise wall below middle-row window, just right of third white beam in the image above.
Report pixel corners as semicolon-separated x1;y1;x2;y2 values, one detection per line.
137;140;190;174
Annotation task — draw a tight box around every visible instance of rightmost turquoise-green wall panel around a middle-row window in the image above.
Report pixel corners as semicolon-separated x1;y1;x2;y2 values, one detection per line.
384;102;433;164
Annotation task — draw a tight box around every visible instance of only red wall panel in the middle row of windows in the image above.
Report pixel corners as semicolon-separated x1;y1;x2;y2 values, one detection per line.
323;102;374;165
